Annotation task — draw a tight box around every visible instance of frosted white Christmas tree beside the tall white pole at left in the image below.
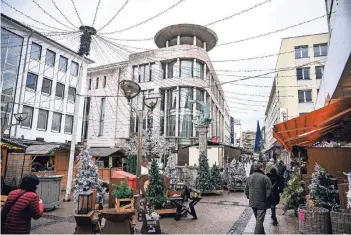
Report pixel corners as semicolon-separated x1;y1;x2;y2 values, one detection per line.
73;150;105;203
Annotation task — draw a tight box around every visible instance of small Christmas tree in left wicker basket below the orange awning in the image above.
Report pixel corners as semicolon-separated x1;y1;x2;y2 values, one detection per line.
309;163;339;210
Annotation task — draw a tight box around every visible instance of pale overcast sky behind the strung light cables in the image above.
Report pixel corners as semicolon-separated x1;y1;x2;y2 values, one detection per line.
2;0;327;130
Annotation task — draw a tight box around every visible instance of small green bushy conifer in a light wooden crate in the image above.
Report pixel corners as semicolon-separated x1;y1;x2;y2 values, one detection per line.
112;182;134;213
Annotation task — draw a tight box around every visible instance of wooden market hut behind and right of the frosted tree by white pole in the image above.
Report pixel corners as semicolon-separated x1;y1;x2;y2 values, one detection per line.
88;147;125;181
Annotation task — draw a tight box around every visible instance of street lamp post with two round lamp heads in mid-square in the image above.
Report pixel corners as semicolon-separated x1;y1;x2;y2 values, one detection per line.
119;80;158;177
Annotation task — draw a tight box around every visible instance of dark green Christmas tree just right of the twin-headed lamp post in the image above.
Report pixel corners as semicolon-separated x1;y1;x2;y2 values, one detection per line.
147;159;167;209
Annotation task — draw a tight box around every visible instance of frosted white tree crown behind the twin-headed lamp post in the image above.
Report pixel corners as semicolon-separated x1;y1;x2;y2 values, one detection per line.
122;129;175;161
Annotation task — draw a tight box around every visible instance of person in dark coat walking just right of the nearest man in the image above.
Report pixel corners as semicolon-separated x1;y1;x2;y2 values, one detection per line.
267;167;284;226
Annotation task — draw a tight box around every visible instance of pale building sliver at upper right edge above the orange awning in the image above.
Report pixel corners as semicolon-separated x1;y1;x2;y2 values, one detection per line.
316;0;351;108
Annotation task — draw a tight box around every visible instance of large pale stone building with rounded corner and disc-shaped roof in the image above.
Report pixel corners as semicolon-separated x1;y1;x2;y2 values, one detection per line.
85;24;230;152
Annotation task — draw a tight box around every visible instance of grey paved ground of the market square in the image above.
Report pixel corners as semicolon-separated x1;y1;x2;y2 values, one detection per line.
31;192;298;234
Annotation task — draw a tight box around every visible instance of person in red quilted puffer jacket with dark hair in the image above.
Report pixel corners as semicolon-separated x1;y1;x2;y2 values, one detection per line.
1;174;44;234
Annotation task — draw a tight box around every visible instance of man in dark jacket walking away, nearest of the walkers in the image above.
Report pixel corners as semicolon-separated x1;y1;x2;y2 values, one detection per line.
245;162;272;234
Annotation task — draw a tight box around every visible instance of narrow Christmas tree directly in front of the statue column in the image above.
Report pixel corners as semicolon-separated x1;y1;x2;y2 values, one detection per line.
196;154;212;192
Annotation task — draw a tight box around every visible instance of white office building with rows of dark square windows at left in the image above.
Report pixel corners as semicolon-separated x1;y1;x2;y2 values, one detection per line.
1;14;93;143
